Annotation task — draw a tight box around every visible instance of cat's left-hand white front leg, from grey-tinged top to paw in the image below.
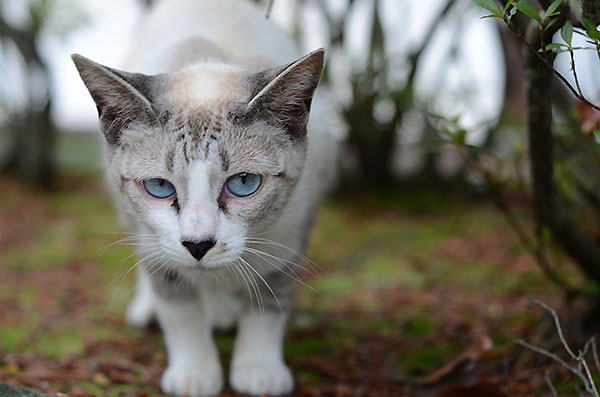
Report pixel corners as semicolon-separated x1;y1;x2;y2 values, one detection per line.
153;270;223;397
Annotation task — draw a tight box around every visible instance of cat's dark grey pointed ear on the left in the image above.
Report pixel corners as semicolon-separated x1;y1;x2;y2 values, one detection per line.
71;54;157;145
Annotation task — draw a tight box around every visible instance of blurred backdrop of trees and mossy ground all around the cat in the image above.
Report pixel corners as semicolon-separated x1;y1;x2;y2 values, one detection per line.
0;0;600;396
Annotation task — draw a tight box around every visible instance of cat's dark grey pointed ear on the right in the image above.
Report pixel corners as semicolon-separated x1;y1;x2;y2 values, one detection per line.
246;48;325;137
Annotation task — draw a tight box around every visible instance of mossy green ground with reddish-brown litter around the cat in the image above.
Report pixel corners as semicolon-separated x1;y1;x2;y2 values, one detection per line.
0;132;592;396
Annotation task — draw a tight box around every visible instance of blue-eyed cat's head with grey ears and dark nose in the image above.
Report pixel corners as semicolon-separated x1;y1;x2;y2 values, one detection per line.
73;49;324;268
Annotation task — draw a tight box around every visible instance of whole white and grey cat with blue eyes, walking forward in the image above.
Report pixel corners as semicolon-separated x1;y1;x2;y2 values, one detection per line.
72;0;338;396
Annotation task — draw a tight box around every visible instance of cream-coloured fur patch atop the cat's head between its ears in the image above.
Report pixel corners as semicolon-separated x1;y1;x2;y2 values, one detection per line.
164;64;241;109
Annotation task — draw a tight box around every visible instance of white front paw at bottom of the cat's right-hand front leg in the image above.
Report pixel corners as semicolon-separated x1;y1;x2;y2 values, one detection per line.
230;361;294;396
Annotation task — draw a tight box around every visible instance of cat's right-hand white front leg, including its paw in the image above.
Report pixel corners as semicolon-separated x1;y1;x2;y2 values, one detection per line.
230;310;294;395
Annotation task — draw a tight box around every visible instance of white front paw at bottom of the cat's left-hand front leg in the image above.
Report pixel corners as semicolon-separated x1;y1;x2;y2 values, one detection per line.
160;366;223;397
